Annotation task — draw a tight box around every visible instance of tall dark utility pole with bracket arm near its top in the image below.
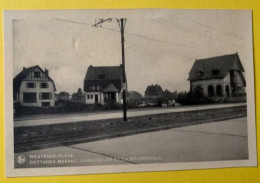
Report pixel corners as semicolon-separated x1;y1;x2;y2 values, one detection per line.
93;18;127;121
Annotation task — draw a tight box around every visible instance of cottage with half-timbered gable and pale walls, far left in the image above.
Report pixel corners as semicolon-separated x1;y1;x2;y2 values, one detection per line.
13;65;56;107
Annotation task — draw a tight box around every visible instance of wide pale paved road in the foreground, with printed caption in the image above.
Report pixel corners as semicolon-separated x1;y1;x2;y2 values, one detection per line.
16;117;248;167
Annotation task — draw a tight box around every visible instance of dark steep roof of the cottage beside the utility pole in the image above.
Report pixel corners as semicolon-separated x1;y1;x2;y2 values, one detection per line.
84;65;123;91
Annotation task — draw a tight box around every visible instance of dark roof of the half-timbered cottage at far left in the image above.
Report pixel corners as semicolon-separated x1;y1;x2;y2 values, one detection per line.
13;65;56;93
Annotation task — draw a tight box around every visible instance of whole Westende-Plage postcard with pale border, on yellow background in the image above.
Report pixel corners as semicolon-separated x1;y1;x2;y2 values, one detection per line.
4;9;257;177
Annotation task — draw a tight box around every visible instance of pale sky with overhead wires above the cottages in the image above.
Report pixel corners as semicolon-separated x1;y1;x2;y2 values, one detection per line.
12;9;252;94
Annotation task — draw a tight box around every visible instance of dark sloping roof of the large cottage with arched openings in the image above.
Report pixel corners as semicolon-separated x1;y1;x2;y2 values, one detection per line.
188;53;244;80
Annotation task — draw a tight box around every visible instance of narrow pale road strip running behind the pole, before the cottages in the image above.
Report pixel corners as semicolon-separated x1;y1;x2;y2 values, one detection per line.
14;103;246;127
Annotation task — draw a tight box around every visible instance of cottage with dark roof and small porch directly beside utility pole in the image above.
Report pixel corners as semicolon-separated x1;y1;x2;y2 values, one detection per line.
84;65;127;104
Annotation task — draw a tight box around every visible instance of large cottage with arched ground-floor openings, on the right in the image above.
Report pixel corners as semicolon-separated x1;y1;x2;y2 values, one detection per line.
188;53;246;102
